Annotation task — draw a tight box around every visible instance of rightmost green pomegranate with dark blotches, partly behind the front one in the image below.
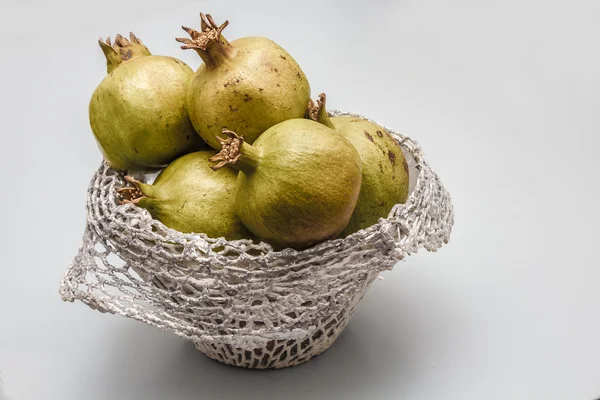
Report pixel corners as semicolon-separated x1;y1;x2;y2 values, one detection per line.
308;94;408;237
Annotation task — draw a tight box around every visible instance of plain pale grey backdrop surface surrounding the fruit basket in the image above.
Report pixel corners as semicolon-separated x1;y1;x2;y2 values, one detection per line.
0;0;600;400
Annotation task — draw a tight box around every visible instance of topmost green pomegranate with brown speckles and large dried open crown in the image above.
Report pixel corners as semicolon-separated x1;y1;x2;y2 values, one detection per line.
176;14;310;150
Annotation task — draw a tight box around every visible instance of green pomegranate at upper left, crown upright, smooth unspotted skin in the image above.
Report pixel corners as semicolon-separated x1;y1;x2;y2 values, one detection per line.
89;33;206;171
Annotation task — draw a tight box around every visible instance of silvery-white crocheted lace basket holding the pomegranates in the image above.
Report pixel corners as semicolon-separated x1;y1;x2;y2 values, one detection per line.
60;111;454;368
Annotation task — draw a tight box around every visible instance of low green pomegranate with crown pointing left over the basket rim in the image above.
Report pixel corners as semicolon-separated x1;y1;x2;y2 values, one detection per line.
119;151;250;240
